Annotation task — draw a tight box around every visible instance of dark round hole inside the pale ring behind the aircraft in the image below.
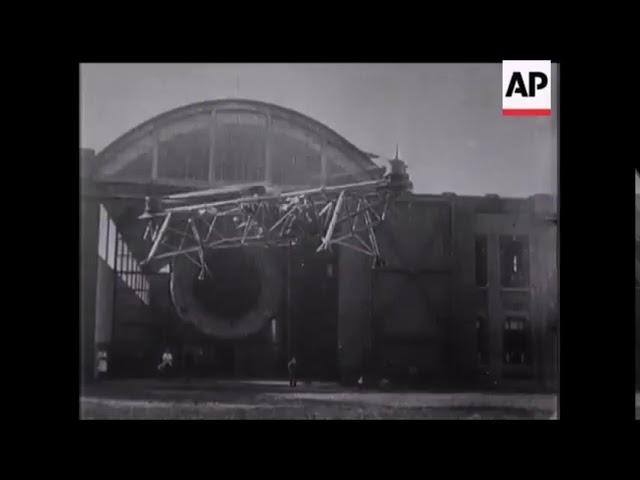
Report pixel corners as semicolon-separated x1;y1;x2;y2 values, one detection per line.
193;248;262;318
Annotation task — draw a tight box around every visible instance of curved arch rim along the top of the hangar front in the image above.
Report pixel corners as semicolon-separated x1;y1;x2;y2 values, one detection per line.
96;99;376;187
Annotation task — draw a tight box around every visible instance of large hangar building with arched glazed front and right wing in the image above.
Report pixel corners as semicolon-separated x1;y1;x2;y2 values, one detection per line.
80;100;559;389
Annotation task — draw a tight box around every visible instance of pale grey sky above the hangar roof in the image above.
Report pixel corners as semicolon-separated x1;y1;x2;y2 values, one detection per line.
80;63;560;196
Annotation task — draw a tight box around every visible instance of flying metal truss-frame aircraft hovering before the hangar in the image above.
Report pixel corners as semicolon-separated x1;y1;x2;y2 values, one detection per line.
140;158;411;278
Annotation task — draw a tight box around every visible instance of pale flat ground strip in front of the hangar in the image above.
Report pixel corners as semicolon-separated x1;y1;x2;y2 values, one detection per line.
80;379;557;420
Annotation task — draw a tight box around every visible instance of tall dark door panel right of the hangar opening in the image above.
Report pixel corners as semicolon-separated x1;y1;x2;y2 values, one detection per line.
373;199;452;377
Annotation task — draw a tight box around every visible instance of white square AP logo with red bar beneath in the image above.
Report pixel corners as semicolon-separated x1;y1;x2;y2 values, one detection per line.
502;60;551;115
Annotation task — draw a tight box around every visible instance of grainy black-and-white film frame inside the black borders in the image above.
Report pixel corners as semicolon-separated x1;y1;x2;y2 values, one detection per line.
79;62;560;420
